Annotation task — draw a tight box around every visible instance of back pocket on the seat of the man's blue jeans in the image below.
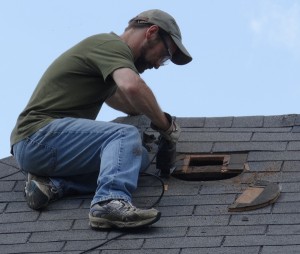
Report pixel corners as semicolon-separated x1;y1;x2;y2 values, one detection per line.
20;138;57;175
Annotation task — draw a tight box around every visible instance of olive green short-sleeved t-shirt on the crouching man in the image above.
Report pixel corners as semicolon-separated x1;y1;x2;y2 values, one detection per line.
11;33;138;145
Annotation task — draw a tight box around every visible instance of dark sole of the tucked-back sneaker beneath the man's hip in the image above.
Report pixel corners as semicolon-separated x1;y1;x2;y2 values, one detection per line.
25;180;49;210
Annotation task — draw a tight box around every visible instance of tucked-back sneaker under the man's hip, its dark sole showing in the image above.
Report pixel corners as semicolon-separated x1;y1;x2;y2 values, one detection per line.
25;173;58;210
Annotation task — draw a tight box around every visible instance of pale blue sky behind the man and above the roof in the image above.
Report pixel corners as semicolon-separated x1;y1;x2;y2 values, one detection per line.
0;0;300;158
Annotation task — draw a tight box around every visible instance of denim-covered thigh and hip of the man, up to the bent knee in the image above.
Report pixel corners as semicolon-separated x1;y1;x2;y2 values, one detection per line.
14;118;137;176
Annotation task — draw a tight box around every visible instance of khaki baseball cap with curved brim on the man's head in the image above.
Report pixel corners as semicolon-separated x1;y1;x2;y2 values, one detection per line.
130;9;193;65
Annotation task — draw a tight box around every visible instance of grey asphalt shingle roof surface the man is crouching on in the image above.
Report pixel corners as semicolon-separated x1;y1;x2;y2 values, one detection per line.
0;115;300;254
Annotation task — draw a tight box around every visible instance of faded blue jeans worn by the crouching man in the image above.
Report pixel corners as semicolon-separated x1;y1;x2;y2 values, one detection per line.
13;118;149;206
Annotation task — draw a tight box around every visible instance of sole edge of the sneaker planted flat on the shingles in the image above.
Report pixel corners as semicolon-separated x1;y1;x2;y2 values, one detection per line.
89;212;161;229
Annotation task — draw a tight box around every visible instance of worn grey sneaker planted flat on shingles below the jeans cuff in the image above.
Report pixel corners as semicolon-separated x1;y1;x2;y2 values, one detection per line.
89;200;160;229
